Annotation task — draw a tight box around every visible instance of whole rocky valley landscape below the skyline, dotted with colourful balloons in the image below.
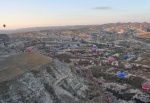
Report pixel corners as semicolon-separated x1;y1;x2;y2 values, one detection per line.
0;22;150;103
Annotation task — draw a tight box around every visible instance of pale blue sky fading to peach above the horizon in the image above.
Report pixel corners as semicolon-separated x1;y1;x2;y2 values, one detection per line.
0;0;150;30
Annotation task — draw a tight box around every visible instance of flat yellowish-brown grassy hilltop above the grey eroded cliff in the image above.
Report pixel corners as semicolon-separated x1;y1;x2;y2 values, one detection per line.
0;52;50;80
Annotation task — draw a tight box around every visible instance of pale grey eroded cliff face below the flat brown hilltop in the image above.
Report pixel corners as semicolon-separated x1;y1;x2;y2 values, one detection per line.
0;60;88;103
